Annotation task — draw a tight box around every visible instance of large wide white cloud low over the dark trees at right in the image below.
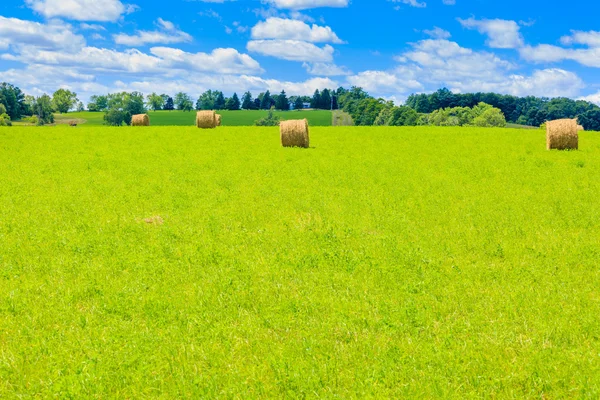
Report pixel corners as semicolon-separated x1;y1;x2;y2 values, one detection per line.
347;39;584;97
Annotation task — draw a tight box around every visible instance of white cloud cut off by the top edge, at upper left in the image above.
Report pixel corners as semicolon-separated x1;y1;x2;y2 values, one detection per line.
25;0;135;22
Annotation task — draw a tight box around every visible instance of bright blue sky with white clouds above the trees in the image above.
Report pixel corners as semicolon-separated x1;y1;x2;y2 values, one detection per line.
0;0;600;104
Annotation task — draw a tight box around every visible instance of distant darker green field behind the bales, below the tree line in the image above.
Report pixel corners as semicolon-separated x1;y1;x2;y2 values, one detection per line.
55;110;331;126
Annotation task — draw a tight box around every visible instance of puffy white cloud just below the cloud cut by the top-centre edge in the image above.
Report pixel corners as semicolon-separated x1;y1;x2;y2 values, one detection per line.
251;17;343;43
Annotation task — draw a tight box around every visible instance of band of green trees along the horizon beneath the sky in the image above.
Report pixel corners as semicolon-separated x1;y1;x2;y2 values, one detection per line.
0;83;600;130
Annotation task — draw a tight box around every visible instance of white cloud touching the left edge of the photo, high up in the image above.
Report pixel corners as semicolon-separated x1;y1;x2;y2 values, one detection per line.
0;16;85;49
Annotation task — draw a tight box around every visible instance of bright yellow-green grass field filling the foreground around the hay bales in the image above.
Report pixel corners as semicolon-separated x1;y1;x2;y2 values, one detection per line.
0;126;600;399
